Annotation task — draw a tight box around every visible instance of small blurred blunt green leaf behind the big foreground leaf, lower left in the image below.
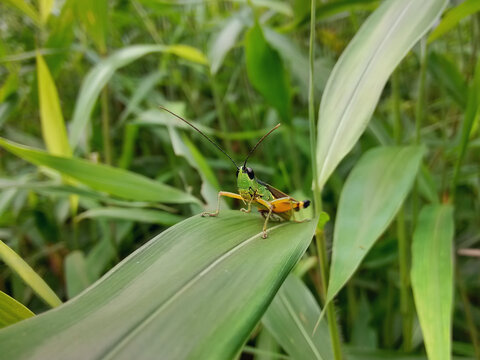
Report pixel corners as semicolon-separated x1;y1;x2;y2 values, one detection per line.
65;250;91;299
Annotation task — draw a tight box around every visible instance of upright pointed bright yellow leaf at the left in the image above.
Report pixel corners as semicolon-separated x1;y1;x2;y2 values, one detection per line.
37;52;72;157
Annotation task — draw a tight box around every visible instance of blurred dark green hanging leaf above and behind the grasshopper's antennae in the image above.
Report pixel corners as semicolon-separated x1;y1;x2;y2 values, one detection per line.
245;23;291;122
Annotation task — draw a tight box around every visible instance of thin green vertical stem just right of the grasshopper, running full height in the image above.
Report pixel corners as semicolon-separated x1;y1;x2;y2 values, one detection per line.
308;0;342;360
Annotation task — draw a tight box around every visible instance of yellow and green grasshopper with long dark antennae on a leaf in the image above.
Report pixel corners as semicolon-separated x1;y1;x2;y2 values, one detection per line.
160;106;310;239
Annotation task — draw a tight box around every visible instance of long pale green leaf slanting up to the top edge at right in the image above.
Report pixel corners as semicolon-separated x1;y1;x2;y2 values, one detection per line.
316;0;447;188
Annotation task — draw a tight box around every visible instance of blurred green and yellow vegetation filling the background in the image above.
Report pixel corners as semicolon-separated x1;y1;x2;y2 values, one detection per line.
0;0;480;356
